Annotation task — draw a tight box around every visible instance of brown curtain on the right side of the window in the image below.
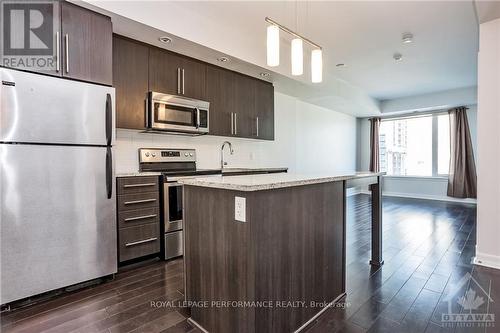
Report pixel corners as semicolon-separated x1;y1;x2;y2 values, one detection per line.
448;107;477;198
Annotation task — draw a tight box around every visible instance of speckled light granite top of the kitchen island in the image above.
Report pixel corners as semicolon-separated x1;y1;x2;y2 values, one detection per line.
179;172;385;191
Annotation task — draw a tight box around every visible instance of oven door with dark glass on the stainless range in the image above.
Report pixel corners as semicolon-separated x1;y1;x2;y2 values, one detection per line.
163;183;182;233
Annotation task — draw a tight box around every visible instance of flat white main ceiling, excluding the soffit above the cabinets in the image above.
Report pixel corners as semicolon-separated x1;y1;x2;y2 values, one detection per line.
169;1;478;100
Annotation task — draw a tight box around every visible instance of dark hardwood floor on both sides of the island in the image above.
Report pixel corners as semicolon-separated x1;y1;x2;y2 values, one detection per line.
1;195;500;333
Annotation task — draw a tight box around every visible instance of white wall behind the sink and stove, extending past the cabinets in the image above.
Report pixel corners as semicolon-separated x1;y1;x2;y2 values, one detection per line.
116;93;356;174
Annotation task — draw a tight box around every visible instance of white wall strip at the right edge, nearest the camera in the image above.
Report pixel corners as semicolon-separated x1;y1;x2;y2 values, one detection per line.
474;19;500;268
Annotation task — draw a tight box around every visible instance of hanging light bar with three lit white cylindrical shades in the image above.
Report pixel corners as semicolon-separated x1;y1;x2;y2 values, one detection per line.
265;17;323;83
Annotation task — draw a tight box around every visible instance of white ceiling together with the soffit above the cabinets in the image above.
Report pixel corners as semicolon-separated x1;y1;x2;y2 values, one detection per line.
83;0;478;116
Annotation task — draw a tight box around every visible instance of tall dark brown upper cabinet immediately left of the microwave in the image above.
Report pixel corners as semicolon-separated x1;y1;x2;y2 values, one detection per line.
113;35;149;130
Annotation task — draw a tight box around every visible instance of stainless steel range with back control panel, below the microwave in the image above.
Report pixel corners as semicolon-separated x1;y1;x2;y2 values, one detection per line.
139;148;220;260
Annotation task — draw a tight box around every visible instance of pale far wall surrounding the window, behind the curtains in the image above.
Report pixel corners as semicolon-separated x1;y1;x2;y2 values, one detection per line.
358;105;478;202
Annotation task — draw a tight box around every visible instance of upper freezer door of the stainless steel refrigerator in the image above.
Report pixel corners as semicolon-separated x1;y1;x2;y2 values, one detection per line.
0;68;115;145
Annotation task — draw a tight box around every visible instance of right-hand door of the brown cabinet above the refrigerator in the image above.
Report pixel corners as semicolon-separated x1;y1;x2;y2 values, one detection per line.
61;2;113;85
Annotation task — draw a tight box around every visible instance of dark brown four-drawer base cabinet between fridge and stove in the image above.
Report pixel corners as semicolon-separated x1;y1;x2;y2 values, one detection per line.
116;176;160;263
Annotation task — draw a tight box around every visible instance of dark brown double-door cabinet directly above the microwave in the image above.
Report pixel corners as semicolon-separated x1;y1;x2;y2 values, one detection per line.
149;47;207;100
